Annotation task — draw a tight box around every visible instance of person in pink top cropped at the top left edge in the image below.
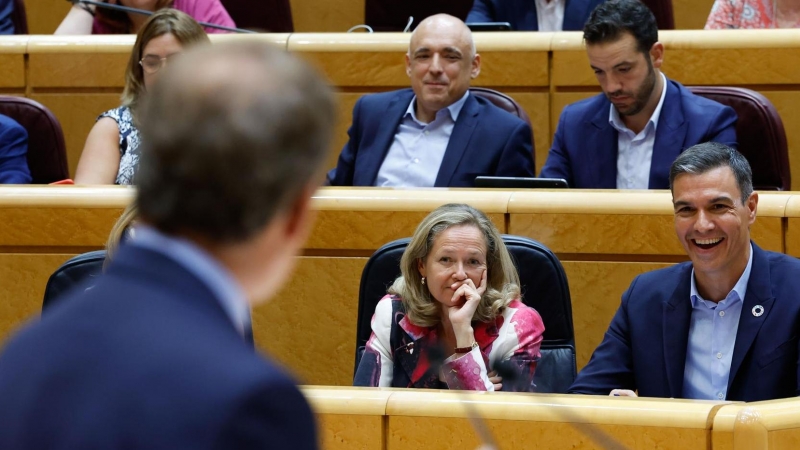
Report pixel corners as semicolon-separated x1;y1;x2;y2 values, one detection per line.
55;0;231;34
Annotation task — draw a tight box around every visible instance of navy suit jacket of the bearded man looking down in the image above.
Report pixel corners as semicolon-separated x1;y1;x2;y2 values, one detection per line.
539;80;736;189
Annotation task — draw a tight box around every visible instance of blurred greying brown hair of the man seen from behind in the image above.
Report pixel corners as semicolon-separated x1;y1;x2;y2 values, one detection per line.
136;41;335;244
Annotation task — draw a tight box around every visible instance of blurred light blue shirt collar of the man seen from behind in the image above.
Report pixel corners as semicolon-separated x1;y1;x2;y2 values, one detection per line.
125;224;250;336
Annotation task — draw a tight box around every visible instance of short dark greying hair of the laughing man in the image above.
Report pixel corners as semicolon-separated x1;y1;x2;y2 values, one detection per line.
669;142;753;204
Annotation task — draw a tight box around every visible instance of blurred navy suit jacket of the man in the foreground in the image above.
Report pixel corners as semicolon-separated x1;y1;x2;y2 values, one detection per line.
0;245;316;449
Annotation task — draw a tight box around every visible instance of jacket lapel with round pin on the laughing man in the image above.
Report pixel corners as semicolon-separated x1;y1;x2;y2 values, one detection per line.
728;244;775;392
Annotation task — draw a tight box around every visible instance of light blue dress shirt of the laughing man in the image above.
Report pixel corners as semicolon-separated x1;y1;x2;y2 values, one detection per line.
683;245;753;400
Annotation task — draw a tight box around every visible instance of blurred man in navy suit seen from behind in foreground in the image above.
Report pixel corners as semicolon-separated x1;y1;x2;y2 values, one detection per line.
0;41;334;449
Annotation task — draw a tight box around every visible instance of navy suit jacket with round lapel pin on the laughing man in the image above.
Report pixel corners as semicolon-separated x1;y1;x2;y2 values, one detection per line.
570;244;800;402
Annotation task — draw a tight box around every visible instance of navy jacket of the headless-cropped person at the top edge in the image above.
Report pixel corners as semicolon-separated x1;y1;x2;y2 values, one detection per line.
467;0;605;31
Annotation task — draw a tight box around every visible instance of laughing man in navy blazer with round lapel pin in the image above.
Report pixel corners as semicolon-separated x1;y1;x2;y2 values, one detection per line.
570;142;800;402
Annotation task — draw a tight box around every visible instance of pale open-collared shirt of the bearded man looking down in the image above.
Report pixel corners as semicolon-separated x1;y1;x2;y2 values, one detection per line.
608;73;667;189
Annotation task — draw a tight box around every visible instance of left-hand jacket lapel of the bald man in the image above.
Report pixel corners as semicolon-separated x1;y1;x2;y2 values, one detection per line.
357;89;414;186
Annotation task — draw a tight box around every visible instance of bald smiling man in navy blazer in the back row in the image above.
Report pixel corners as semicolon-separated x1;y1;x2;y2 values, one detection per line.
328;14;534;187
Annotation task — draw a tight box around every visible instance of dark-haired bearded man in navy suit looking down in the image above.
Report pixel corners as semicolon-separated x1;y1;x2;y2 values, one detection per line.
540;0;736;189
